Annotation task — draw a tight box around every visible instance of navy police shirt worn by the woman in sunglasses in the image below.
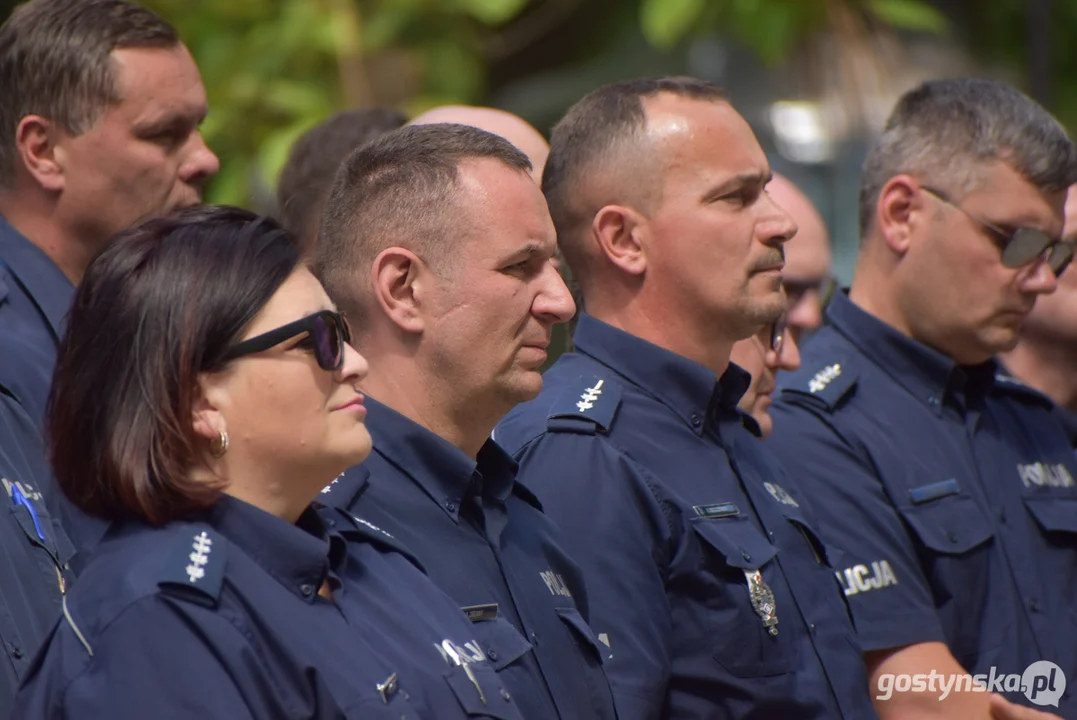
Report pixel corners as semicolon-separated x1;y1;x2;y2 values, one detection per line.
14;496;520;720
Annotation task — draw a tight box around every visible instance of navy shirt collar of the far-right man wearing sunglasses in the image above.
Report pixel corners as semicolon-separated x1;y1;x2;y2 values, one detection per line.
826;293;995;414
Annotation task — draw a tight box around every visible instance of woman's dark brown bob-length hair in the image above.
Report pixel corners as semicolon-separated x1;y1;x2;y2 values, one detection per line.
46;207;299;524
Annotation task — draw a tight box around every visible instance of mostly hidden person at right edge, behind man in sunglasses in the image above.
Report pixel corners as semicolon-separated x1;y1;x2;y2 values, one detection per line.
1003;185;1077;448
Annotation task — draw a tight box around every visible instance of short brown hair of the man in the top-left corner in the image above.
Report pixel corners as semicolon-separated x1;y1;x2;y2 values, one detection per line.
0;0;180;185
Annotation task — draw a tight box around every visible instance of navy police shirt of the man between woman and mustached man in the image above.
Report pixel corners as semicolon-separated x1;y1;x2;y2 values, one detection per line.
320;398;615;720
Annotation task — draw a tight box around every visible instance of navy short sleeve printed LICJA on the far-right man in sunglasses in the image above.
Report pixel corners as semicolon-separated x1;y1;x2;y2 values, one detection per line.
767;403;946;650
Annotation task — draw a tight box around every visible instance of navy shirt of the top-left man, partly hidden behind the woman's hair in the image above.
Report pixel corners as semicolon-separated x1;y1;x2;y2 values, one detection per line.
0;217;104;559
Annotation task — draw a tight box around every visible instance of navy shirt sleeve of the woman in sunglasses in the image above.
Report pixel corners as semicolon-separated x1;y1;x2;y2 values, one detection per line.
13;596;269;720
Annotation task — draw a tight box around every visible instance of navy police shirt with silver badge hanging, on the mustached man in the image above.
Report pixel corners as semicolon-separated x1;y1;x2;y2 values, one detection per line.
494;314;876;720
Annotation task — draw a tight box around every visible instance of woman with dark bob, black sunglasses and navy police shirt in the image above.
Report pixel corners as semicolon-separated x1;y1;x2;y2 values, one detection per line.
13;208;519;720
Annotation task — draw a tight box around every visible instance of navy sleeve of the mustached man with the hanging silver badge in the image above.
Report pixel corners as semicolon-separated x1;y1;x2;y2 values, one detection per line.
518;433;672;720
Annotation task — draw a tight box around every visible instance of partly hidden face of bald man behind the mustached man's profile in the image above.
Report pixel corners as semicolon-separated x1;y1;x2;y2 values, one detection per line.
767;173;834;341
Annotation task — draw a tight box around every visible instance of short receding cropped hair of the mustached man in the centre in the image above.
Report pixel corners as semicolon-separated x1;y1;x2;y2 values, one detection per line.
542;76;727;282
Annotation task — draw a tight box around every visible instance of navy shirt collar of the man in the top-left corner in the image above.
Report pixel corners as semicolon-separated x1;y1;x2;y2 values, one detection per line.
0;216;74;342
